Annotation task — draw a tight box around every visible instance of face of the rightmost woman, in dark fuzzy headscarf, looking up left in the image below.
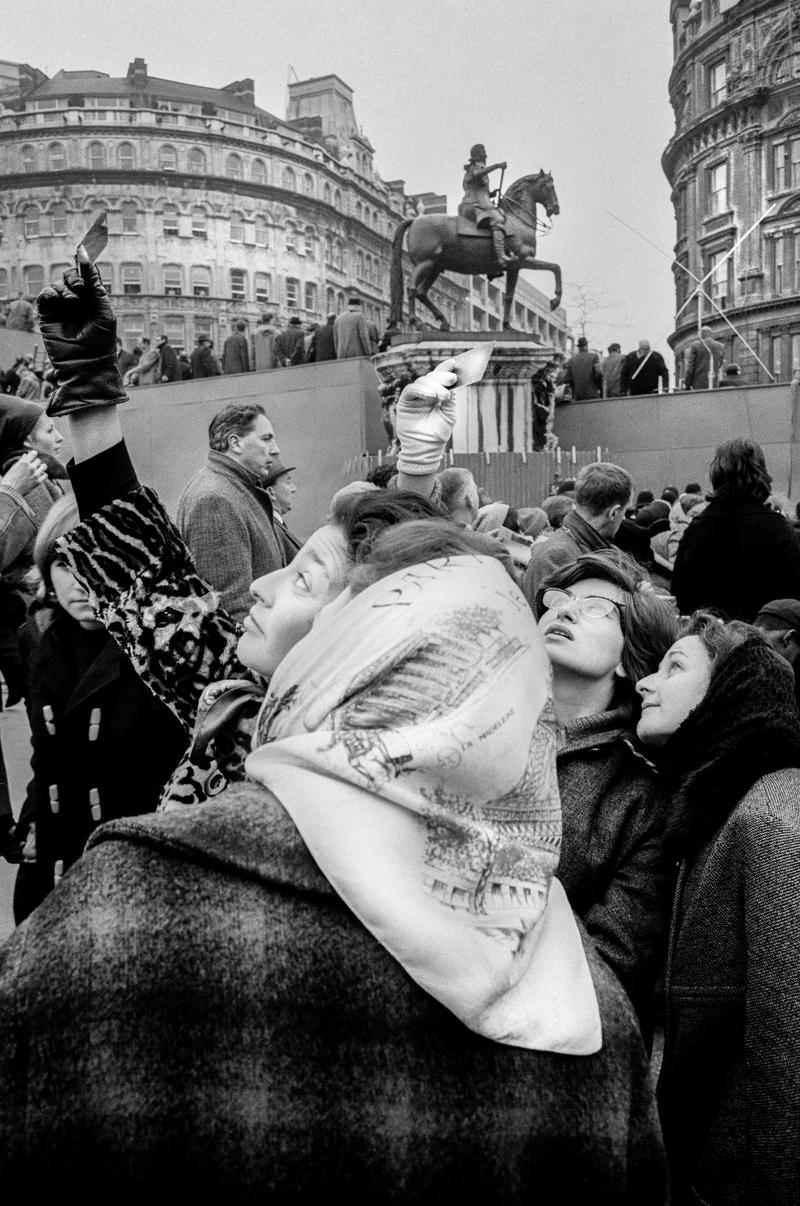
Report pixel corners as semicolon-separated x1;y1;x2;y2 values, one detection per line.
636;637;712;745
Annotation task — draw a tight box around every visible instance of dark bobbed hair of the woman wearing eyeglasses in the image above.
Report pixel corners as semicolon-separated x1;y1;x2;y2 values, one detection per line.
535;549;681;704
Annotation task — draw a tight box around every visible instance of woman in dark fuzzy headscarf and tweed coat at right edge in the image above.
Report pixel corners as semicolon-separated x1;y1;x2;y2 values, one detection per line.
637;611;800;1206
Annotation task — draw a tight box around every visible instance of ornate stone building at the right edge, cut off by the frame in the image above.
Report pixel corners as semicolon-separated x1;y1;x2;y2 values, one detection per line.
662;0;800;382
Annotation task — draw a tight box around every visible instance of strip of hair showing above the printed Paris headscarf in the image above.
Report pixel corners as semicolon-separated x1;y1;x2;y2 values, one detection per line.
350;518;519;593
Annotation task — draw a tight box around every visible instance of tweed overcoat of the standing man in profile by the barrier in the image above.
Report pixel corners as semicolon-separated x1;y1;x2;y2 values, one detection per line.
177;450;285;620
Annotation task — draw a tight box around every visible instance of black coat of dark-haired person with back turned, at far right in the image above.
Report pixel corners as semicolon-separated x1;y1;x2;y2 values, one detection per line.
672;498;800;624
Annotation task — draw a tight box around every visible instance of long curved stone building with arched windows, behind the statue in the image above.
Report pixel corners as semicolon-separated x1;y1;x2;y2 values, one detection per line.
0;58;567;350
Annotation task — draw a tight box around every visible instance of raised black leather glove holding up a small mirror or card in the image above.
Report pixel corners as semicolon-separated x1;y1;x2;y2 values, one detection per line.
36;252;128;416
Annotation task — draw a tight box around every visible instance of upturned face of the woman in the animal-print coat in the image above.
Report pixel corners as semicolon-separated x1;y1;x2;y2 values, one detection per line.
237;523;352;678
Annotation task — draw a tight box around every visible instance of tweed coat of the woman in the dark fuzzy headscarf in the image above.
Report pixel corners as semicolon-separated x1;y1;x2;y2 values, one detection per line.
659;769;800;1206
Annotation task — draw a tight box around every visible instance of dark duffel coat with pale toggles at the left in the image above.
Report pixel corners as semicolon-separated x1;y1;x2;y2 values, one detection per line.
14;608;186;921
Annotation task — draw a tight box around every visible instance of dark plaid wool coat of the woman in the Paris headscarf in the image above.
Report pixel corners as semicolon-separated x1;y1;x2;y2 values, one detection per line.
0;784;667;1206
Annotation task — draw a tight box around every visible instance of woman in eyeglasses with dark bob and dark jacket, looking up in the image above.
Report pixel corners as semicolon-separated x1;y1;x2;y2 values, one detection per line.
536;550;677;1043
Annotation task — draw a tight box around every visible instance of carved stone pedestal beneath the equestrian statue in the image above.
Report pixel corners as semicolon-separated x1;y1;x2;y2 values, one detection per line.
373;330;560;452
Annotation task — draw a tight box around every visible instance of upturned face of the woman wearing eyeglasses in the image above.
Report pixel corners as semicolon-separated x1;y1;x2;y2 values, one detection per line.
538;578;625;686
